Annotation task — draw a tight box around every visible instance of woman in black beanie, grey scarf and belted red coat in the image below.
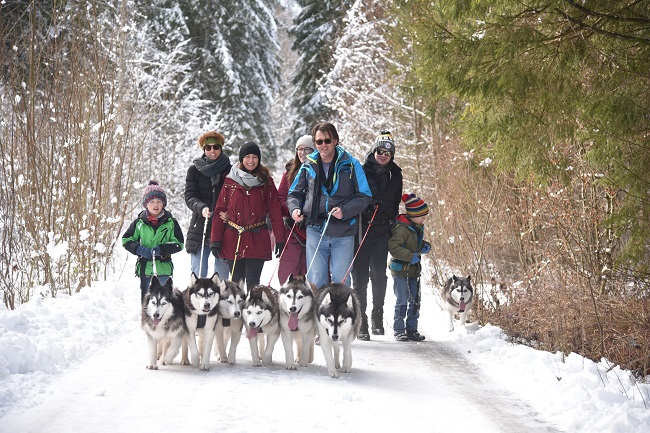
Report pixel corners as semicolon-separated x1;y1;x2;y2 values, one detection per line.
210;142;285;289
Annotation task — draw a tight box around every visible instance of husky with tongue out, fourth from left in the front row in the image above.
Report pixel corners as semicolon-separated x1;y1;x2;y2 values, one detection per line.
243;285;280;367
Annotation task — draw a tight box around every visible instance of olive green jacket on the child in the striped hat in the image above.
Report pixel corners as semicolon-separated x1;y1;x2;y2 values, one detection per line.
388;214;428;278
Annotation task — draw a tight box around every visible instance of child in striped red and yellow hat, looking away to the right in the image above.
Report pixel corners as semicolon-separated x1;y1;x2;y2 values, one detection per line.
388;194;431;341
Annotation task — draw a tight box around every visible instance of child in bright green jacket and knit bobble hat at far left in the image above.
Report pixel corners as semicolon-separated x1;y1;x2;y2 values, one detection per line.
122;180;184;301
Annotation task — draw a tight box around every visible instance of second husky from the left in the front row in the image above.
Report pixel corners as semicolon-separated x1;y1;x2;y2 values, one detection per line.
181;272;220;371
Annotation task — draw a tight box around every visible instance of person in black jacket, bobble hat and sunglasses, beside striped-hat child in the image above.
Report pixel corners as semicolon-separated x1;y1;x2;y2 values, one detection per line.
352;131;402;341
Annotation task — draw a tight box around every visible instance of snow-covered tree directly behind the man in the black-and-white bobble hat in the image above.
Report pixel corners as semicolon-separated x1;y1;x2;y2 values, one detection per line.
320;0;413;157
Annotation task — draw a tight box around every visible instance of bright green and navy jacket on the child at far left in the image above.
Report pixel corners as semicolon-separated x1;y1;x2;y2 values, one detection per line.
122;210;184;277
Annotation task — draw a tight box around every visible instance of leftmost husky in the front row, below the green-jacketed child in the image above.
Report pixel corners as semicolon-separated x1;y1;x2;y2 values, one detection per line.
141;276;187;370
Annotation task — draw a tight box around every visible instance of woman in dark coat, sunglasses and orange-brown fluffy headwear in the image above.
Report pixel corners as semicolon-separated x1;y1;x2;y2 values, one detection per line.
185;131;232;279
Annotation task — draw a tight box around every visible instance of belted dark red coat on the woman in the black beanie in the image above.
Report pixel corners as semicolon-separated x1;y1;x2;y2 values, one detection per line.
210;177;285;260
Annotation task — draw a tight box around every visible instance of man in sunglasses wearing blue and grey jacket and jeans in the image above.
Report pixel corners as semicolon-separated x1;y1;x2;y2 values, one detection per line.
287;123;372;289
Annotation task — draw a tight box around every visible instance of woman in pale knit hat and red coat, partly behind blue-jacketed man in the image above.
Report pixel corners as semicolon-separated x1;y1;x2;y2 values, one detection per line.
278;135;314;284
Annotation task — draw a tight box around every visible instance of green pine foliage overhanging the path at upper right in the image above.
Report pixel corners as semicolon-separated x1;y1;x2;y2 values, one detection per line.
397;0;650;273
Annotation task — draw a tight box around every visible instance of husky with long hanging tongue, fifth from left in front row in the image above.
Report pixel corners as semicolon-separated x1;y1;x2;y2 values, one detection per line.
280;275;318;370
